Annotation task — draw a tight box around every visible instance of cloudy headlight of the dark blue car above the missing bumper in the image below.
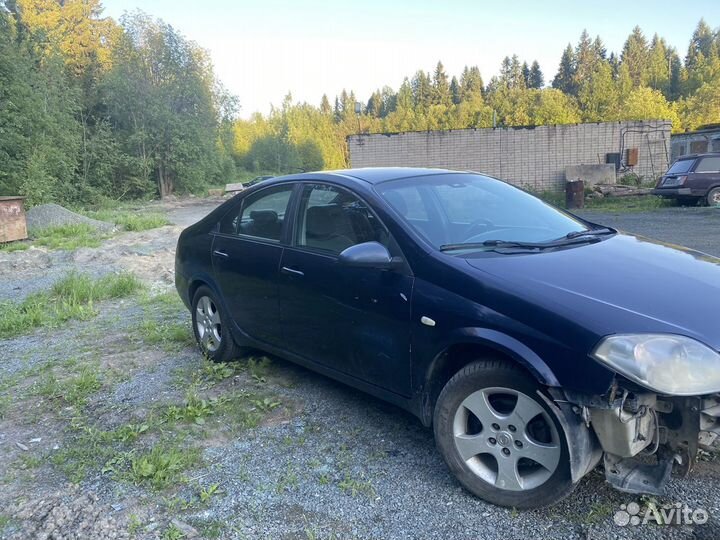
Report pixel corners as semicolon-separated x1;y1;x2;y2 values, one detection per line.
592;334;720;396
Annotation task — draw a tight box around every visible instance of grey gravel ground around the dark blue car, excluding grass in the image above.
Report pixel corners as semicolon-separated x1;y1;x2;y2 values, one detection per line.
0;201;720;539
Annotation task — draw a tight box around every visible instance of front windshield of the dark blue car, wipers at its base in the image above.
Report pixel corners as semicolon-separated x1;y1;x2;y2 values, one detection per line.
377;173;589;249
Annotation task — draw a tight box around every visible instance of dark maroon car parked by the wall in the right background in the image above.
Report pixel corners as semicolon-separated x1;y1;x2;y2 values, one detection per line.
653;152;720;206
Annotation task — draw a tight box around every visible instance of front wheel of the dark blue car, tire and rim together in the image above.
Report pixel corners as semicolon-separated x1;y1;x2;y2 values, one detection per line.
434;360;575;508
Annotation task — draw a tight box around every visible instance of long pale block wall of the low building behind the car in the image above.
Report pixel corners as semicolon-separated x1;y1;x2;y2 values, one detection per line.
347;120;671;191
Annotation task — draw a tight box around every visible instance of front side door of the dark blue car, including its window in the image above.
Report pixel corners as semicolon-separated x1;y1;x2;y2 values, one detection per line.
278;183;413;395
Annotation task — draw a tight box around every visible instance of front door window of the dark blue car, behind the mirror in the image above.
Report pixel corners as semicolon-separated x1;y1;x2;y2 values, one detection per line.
295;184;390;254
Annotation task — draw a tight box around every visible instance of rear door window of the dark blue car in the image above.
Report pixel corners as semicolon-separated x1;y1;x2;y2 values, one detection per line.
220;185;293;242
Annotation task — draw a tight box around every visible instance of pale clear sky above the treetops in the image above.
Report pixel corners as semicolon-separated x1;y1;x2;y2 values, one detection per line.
103;0;720;118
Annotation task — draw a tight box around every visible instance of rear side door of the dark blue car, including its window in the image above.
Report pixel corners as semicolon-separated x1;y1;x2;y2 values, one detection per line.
212;184;295;345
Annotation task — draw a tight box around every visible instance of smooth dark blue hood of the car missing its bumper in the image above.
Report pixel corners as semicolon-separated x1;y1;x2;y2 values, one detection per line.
467;233;720;350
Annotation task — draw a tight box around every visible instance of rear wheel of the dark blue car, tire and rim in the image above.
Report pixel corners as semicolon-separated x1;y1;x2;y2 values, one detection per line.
191;285;240;362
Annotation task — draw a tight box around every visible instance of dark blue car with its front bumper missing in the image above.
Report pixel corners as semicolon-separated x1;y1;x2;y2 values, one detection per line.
175;168;720;508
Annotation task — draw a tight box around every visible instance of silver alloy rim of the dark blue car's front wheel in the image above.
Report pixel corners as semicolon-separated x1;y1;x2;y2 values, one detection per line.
453;387;562;491
